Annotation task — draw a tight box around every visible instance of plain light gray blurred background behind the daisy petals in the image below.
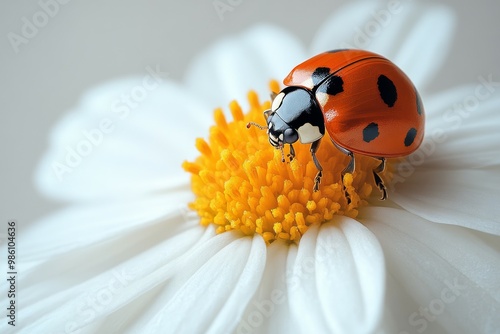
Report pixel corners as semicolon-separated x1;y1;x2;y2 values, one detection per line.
0;0;500;223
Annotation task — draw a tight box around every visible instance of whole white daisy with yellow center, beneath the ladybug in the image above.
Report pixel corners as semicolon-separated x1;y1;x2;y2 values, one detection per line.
8;2;500;333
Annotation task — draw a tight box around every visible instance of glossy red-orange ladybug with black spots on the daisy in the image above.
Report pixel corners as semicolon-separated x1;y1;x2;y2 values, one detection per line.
247;49;425;202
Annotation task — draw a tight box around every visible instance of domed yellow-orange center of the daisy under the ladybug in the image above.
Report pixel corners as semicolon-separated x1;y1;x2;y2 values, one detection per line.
182;82;390;244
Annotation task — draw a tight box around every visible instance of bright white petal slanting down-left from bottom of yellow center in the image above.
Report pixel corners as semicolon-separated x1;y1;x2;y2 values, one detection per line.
137;236;266;333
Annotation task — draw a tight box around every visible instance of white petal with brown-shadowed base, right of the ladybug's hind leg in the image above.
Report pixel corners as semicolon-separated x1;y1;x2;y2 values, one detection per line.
391;168;500;235
